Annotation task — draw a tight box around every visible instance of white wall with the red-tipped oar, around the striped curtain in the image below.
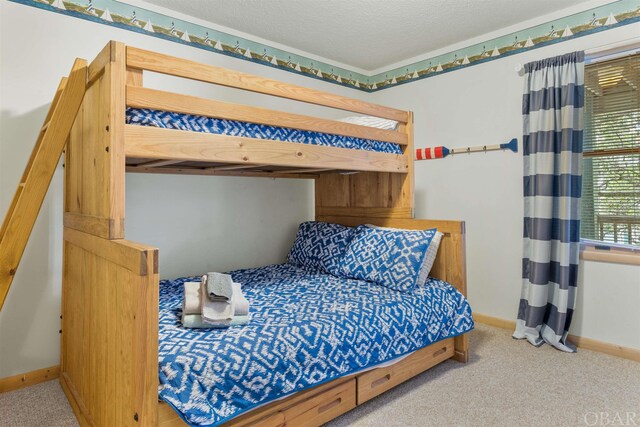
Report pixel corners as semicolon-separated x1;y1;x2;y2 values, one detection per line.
372;24;640;348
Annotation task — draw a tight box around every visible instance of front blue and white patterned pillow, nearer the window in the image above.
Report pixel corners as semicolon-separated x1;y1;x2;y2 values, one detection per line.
340;225;436;292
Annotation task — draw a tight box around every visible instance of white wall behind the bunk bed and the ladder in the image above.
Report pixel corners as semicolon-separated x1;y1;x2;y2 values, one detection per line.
0;1;367;378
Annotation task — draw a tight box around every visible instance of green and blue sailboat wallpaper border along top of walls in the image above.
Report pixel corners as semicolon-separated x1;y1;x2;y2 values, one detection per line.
10;0;640;92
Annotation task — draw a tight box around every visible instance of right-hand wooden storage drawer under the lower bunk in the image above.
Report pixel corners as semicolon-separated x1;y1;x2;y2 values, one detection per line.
357;338;454;405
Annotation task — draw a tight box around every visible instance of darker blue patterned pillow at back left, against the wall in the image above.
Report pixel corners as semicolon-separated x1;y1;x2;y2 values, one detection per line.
287;221;355;276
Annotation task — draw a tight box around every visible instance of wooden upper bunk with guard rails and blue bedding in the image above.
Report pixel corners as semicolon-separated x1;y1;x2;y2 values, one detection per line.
84;42;413;178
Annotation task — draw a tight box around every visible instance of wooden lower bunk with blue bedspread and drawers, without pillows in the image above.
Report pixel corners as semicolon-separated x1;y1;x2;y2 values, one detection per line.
60;216;473;427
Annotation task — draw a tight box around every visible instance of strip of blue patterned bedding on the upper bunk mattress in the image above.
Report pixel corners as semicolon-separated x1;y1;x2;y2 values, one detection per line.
126;108;402;154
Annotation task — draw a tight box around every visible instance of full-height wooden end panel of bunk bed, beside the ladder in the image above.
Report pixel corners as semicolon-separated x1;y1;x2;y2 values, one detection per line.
60;42;158;426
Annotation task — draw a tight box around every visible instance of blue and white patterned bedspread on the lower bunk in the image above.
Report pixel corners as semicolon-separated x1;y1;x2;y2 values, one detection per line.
159;264;474;425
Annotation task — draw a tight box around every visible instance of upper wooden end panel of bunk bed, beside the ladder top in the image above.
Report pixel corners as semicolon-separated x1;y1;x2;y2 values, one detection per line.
64;42;126;239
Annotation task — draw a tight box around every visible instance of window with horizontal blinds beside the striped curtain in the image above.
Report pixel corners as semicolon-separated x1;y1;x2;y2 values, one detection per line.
580;54;640;251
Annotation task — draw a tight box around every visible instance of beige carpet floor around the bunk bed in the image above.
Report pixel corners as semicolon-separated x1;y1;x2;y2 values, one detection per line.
0;325;640;427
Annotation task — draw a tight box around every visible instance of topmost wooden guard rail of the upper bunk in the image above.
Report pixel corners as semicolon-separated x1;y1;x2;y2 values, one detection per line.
127;46;409;123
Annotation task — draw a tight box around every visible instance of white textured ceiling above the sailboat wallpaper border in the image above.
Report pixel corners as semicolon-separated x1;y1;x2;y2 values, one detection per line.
147;0;596;71
